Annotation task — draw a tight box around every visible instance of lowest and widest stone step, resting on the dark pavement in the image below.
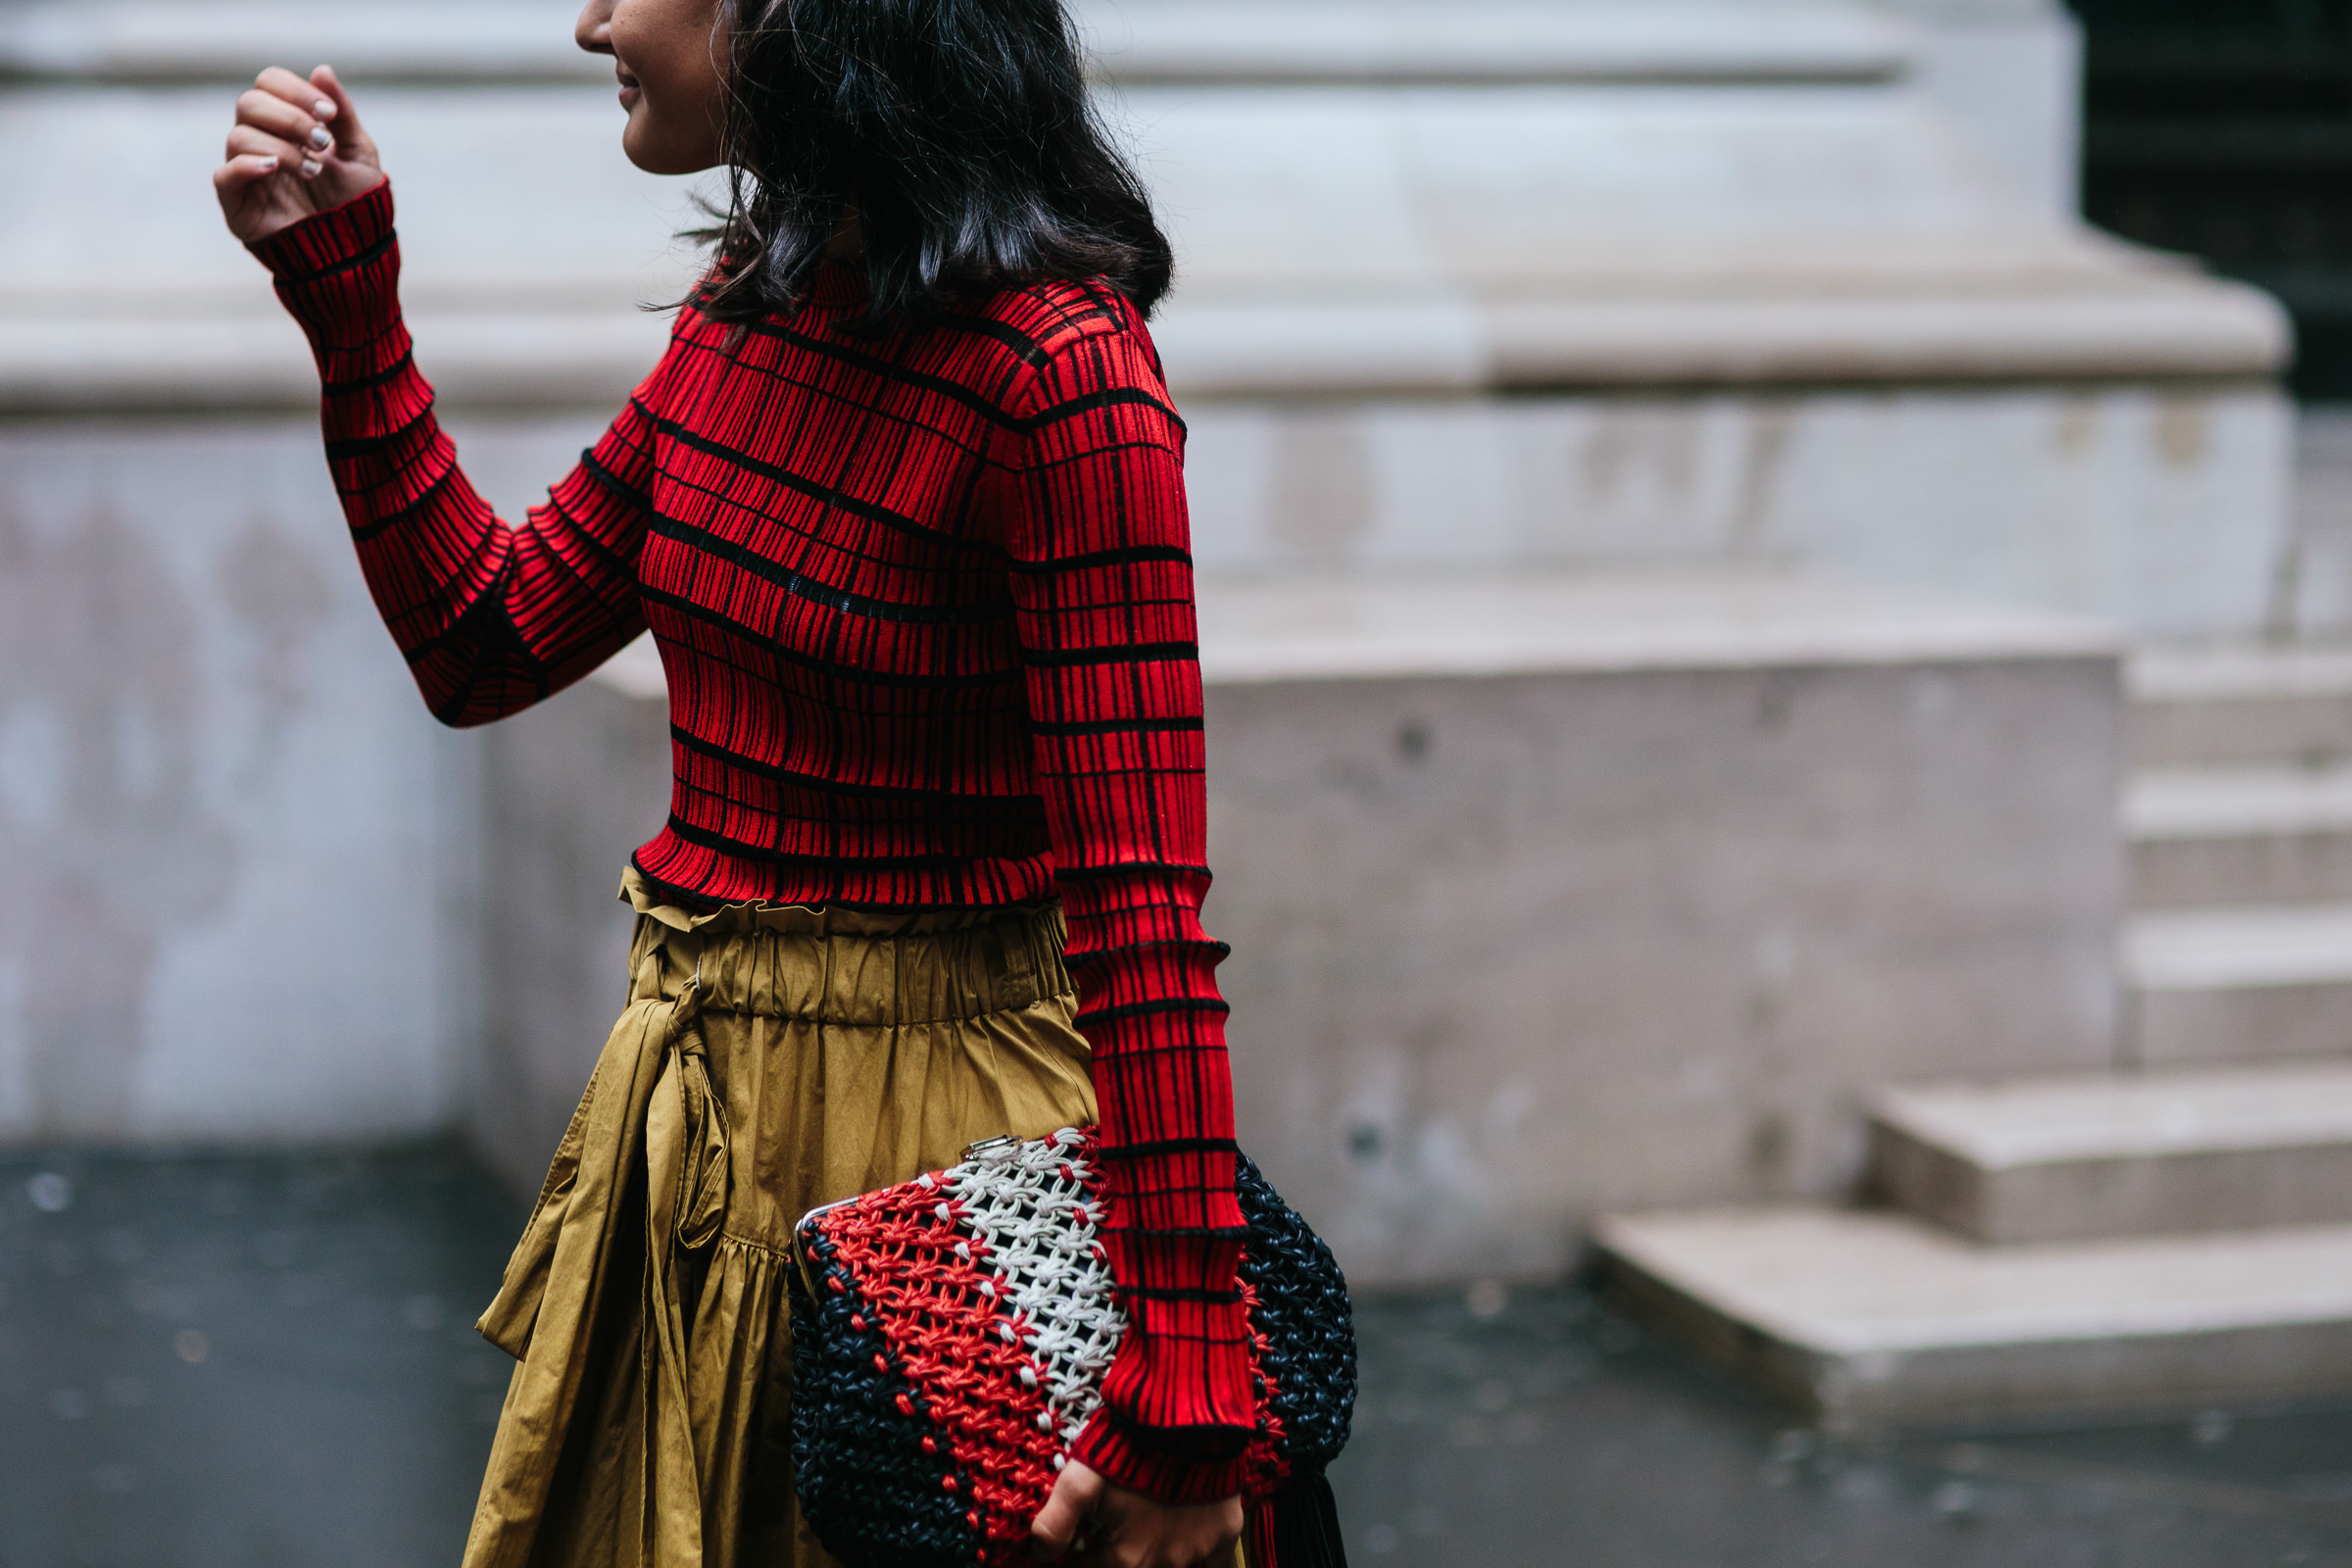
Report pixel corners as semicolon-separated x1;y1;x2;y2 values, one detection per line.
1597;1206;2352;1429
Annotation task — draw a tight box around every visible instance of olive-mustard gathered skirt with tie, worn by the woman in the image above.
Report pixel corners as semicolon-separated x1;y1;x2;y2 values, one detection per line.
466;879;1094;1568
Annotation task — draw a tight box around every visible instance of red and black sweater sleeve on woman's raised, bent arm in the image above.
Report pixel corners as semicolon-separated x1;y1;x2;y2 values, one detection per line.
252;181;663;726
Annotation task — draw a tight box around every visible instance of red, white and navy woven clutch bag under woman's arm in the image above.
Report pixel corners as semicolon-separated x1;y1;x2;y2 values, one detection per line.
790;1128;1354;1568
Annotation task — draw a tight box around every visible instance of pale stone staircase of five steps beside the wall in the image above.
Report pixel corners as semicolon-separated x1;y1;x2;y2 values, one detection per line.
1597;651;2352;1427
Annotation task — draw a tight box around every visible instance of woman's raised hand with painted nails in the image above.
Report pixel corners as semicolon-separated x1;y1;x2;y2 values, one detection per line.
212;66;383;244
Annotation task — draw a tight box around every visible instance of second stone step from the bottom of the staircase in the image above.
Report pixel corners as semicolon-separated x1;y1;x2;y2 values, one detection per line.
1870;1060;2352;1244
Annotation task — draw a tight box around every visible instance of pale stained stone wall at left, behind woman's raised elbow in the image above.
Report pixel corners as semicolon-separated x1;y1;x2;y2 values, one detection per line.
0;416;612;1143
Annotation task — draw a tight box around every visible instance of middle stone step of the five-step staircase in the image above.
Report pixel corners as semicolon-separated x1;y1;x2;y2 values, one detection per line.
2124;903;2352;1067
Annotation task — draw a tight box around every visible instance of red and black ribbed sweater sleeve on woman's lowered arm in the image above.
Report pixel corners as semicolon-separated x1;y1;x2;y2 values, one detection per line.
1004;301;1256;1502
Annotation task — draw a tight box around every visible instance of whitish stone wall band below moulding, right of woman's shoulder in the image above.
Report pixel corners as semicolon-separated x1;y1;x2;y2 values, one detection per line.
1186;385;2285;635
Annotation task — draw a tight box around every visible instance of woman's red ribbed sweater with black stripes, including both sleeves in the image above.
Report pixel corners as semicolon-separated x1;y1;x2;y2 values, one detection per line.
254;186;1251;1499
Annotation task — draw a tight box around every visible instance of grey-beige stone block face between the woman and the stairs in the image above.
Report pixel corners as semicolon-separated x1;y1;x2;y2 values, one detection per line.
1209;661;2117;1281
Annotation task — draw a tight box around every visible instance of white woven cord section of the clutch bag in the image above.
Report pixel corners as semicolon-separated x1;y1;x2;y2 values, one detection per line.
941;1128;1127;1450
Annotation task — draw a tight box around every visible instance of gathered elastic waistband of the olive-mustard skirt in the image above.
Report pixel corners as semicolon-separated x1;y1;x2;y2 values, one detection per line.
621;867;1070;1027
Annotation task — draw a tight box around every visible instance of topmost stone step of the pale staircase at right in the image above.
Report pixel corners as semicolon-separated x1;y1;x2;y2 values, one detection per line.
2129;647;2352;766
